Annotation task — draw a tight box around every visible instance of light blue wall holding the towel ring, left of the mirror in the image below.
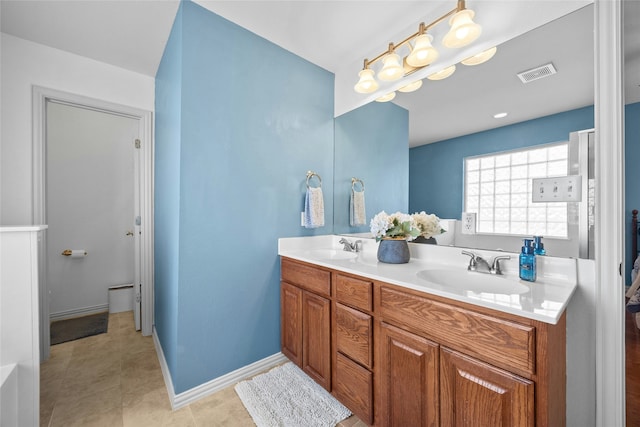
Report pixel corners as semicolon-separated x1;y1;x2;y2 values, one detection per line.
155;2;334;393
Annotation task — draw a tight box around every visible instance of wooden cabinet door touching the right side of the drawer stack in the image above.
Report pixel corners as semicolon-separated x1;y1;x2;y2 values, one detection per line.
376;323;439;427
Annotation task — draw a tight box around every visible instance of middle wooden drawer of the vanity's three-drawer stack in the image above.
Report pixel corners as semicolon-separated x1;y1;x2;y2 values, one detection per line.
335;303;373;369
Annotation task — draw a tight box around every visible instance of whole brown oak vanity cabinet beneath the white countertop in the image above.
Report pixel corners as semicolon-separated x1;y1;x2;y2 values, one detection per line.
281;258;566;427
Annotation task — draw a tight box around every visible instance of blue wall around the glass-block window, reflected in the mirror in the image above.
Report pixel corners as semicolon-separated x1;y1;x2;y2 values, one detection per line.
409;106;594;219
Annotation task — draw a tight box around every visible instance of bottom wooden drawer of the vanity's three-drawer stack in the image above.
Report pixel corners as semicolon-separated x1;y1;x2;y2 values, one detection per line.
333;353;373;425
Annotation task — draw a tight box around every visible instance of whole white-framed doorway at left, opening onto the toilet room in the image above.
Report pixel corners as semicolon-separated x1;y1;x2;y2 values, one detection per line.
33;87;153;360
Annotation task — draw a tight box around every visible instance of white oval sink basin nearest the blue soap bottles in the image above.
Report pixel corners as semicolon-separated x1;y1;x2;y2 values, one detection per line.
416;269;529;295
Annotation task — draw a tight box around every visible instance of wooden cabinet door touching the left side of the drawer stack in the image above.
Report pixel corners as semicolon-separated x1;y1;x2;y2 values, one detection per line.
302;291;331;391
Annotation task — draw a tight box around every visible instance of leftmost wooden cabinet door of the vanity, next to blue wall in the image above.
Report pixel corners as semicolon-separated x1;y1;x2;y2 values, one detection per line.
280;282;302;368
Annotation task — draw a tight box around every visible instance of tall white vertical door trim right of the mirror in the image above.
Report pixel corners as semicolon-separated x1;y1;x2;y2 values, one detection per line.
594;0;626;427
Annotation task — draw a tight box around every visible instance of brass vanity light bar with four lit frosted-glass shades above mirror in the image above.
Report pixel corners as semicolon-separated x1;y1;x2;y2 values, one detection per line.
354;0;482;93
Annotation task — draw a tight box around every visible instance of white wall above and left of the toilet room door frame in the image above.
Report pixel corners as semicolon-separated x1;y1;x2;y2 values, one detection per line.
0;33;155;225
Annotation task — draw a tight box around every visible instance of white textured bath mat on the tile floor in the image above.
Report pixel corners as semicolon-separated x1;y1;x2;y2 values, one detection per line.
235;362;351;427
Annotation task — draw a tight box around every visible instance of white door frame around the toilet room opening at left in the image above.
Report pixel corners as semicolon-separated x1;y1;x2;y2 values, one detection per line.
31;85;154;348
